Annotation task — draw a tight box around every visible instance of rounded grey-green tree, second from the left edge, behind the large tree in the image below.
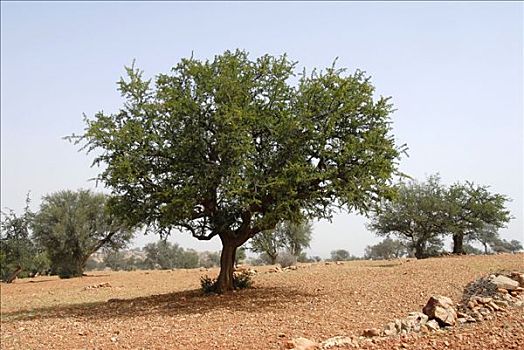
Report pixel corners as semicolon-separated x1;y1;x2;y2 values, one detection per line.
33;190;133;278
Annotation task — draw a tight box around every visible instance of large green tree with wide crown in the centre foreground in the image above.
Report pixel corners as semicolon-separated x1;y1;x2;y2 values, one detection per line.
73;50;402;292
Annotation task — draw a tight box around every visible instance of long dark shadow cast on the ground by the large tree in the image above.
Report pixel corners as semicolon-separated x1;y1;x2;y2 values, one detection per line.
2;287;317;322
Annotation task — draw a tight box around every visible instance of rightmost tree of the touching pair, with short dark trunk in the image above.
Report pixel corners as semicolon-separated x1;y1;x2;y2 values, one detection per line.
445;182;511;254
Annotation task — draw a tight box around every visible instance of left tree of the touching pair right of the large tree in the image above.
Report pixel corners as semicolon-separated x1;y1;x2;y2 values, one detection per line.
368;175;449;259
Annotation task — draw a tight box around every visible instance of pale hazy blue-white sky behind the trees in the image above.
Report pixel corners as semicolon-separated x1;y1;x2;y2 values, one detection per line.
1;2;524;257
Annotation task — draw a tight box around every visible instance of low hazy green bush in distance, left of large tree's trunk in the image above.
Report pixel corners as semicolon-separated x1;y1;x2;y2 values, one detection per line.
144;240;199;270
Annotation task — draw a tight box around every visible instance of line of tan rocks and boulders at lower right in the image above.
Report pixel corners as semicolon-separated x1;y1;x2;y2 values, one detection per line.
284;272;524;350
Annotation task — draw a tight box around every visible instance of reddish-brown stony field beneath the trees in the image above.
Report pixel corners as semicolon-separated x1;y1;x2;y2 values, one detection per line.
0;254;524;349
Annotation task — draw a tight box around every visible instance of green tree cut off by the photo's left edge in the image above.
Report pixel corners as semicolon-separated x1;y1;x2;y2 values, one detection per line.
0;194;49;283
